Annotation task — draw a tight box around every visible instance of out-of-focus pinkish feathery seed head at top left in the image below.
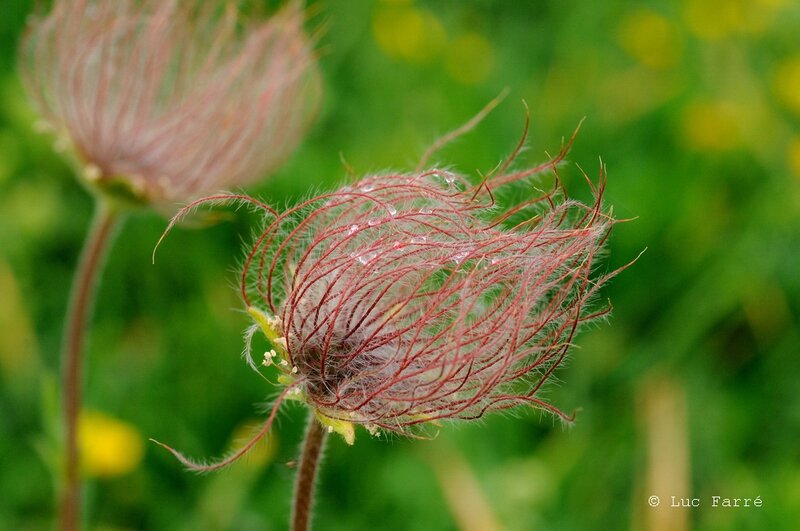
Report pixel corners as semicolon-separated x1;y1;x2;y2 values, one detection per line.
21;0;319;211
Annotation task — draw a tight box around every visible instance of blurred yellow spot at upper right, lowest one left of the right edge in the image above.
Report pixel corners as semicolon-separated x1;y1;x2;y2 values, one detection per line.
682;102;741;151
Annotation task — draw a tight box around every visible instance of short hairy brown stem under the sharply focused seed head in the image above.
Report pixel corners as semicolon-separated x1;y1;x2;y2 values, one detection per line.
292;413;328;531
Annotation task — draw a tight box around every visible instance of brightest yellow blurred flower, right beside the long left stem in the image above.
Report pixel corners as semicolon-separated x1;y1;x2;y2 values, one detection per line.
78;411;144;478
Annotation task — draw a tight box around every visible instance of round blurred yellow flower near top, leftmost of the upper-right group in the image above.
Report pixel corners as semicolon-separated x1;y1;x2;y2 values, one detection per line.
617;9;682;69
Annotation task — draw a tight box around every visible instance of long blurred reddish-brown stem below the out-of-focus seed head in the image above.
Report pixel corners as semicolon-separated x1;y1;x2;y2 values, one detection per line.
59;199;119;531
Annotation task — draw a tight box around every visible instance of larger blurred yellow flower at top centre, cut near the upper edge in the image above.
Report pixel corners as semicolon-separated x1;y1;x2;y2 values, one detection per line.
372;5;447;63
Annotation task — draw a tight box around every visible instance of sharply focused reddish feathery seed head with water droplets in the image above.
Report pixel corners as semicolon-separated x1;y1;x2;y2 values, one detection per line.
242;142;614;442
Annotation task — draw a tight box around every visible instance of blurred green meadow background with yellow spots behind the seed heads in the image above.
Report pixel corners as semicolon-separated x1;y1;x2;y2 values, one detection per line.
0;0;800;531
